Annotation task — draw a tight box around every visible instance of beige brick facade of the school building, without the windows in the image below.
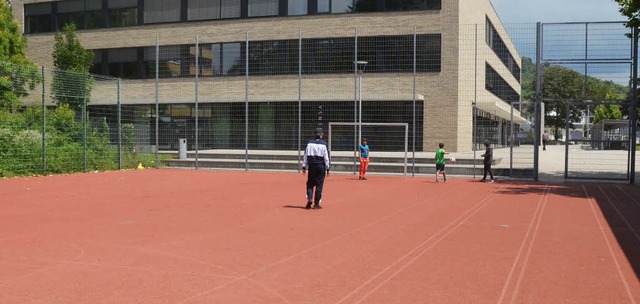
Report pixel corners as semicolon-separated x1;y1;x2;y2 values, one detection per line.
13;0;520;151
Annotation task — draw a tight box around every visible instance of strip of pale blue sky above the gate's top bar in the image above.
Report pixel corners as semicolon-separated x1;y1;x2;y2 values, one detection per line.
491;0;626;24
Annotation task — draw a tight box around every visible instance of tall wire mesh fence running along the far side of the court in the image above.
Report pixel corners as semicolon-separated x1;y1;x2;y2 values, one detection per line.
0;22;637;180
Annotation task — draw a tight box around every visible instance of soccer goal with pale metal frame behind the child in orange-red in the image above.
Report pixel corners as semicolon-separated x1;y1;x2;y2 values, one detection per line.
327;122;409;177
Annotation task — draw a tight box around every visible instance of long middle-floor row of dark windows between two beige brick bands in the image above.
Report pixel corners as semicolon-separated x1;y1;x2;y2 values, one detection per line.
91;34;442;79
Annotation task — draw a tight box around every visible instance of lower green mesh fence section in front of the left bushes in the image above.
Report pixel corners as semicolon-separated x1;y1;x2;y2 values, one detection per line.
0;63;159;177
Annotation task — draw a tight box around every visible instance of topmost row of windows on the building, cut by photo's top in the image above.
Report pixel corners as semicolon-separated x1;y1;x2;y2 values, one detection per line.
25;0;442;34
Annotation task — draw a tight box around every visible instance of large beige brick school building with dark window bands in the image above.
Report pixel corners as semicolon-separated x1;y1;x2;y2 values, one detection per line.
12;0;527;151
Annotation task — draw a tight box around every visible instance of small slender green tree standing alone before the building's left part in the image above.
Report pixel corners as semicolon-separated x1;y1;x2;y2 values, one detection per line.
52;23;94;109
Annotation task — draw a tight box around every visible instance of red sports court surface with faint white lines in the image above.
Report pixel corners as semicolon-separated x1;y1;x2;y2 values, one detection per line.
0;170;640;303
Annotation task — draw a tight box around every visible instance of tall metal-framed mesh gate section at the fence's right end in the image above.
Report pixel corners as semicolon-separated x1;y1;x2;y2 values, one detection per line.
534;22;637;181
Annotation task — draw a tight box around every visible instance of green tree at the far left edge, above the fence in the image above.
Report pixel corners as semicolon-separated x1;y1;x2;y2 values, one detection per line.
0;1;40;111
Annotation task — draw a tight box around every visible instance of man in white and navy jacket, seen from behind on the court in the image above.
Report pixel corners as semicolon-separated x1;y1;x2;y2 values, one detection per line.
302;129;329;209
